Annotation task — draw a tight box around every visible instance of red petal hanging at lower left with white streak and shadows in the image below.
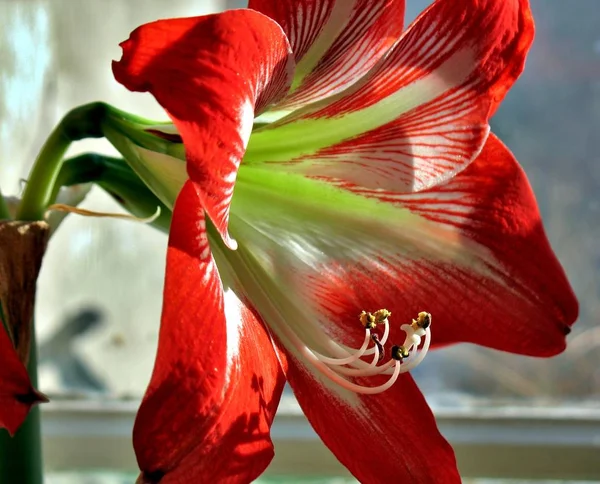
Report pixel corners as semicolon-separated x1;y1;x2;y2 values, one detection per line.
133;181;285;484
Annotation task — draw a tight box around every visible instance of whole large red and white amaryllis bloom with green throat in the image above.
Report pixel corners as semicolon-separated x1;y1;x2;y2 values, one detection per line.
114;0;577;483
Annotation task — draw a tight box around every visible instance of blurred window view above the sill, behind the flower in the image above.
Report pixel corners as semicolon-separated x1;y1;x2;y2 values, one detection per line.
0;0;600;483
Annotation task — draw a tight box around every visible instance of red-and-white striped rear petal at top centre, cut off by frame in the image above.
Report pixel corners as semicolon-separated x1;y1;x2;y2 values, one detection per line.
248;0;405;110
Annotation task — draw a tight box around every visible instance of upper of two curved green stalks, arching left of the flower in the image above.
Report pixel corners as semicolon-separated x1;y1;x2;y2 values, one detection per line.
17;103;108;220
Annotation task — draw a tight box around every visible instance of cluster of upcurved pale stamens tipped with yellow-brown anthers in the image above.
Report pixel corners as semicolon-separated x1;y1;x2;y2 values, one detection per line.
290;309;431;395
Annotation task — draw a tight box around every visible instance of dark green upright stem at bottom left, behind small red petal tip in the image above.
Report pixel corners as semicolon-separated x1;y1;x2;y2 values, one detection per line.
0;326;43;484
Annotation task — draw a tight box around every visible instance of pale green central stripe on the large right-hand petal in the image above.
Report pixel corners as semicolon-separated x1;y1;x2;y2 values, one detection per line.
232;166;490;273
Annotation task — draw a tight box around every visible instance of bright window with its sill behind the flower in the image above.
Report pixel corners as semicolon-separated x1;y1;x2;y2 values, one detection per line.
0;0;600;484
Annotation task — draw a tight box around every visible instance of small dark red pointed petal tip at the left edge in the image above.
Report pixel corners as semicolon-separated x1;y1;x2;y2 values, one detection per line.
0;321;48;435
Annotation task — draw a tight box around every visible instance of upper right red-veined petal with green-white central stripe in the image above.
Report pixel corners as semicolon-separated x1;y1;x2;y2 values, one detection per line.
247;0;533;193
